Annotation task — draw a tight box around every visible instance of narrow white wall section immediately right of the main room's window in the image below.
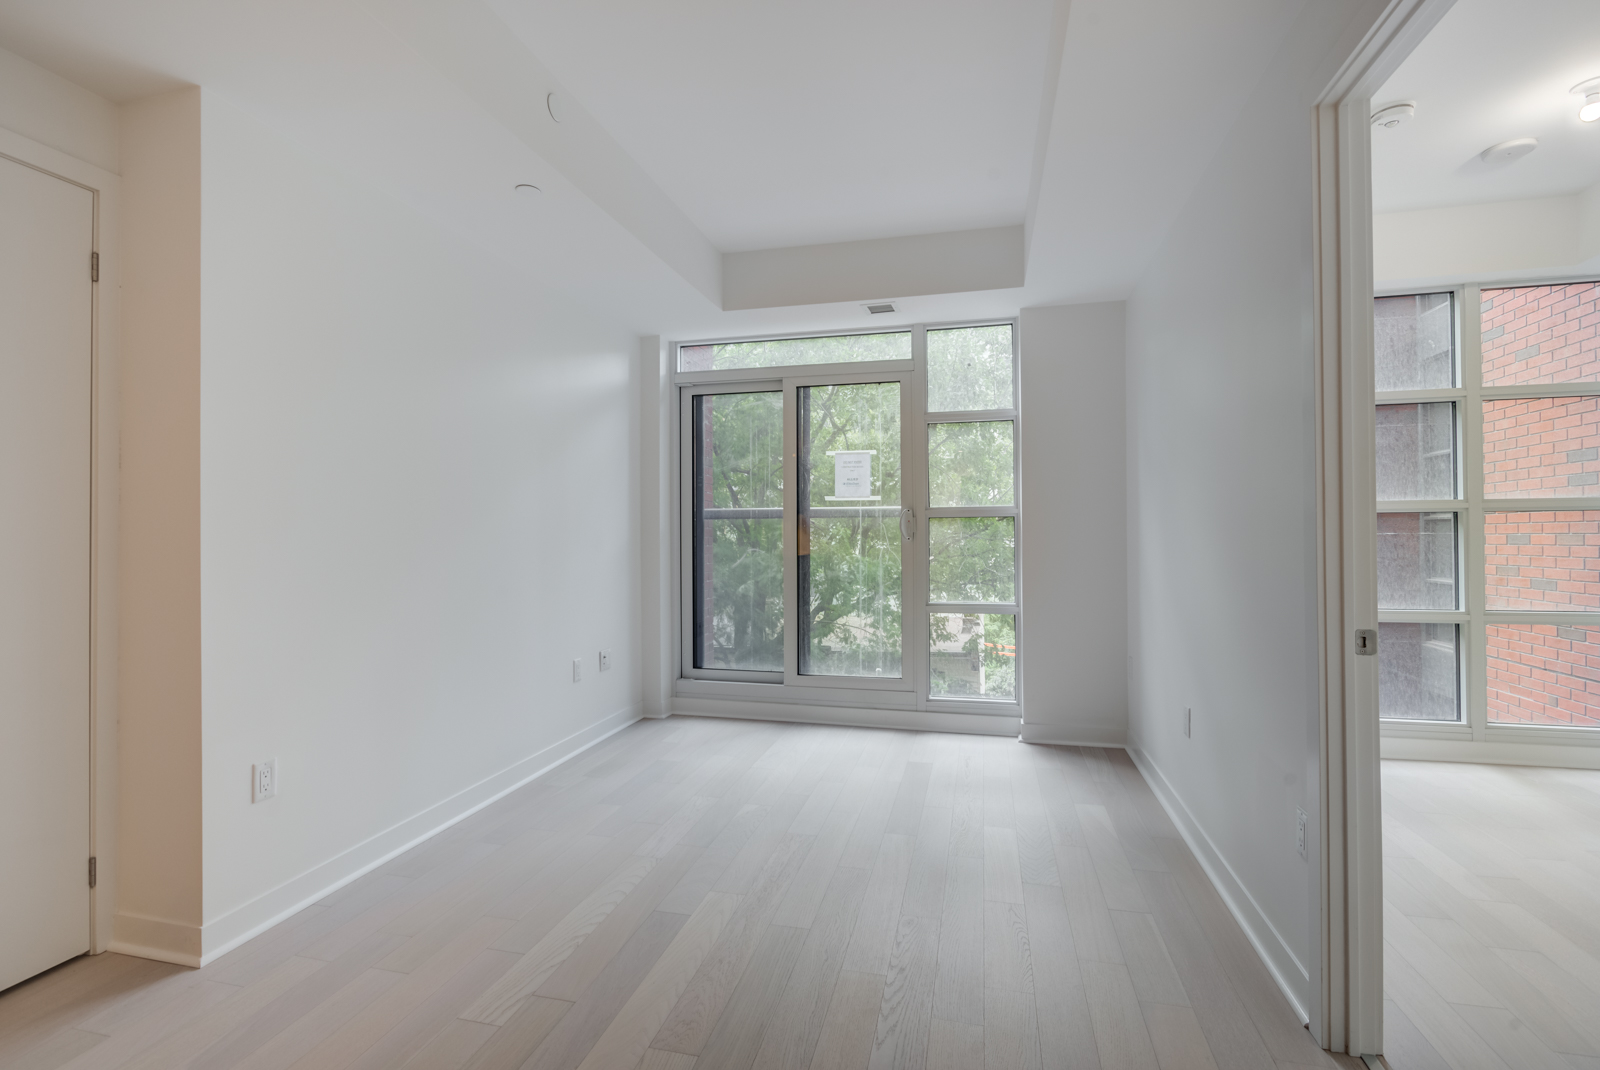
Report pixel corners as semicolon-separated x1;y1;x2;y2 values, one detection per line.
1019;301;1128;744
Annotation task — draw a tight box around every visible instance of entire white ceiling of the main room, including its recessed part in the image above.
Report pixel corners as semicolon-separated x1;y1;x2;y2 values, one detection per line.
0;0;1310;329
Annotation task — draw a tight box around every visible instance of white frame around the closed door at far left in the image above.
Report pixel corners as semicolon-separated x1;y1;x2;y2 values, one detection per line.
0;128;120;955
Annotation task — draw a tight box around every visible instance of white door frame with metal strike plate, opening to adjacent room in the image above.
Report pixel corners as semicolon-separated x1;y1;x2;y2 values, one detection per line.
1310;0;1454;1056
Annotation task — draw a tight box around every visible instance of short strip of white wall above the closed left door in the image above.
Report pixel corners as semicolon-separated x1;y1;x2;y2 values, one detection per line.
0;48;120;174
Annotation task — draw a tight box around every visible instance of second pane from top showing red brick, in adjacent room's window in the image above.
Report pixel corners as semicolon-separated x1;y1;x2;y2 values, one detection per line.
1483;398;1600;497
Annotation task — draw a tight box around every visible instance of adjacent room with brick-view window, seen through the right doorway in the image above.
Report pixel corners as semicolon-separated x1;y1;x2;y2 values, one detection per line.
1371;0;1600;1070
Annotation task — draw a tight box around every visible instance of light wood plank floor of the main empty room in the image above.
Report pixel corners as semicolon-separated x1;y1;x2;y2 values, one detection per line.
0;718;1363;1070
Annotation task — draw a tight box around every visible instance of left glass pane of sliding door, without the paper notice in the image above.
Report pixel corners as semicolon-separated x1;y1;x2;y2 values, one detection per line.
693;390;784;672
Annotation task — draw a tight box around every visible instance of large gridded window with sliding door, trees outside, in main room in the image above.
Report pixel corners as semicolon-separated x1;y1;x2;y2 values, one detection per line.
677;321;1021;715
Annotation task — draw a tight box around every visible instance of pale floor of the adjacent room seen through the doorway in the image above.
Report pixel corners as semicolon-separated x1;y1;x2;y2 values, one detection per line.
1382;761;1600;1070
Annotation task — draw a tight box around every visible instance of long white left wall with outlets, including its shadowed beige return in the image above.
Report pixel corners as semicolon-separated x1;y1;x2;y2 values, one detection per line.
108;90;640;963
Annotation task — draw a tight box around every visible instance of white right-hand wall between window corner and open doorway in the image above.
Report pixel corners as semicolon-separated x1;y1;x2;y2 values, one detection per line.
1128;0;1382;1009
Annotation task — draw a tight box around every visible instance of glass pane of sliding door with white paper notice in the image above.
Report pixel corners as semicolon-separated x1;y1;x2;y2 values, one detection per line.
797;382;901;677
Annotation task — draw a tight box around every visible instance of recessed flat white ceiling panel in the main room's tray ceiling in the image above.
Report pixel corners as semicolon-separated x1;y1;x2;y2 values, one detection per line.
490;0;1051;251
